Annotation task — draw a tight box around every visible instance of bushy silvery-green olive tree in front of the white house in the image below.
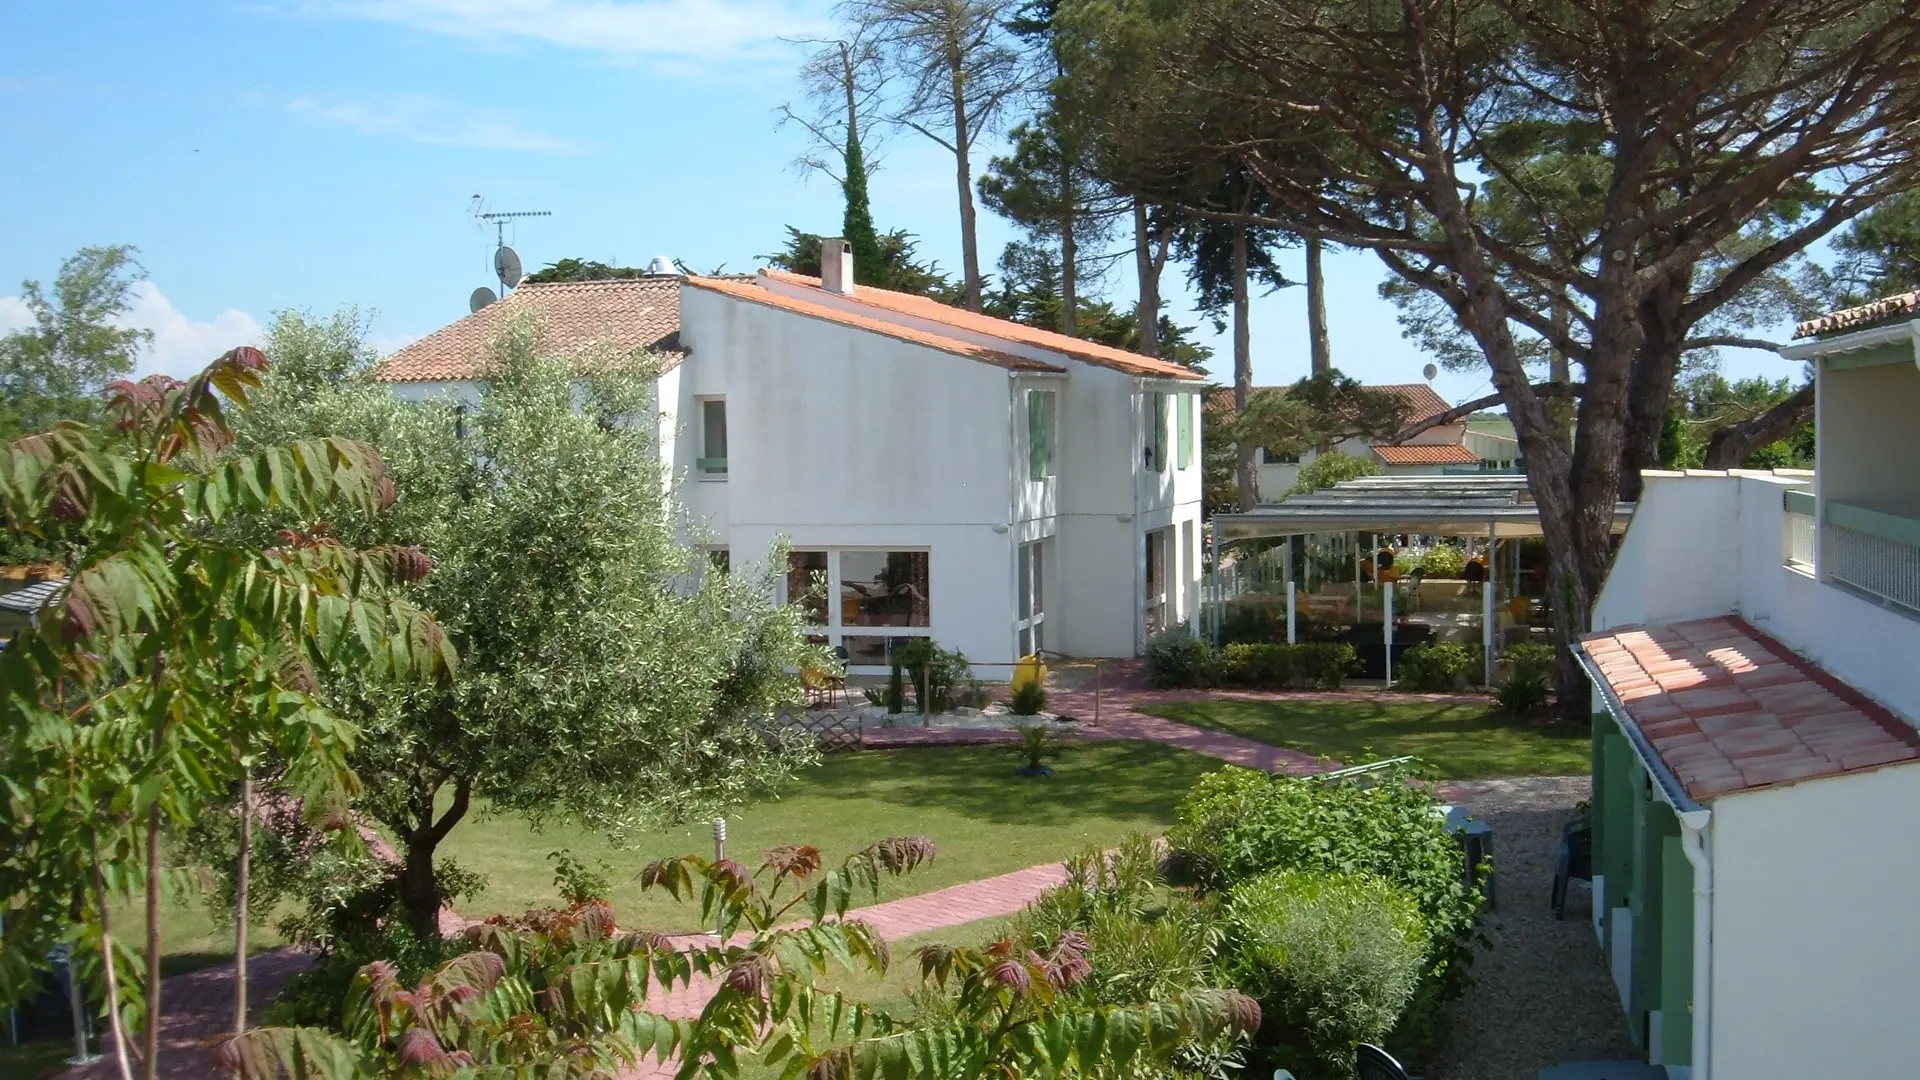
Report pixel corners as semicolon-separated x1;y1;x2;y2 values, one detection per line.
232;315;816;936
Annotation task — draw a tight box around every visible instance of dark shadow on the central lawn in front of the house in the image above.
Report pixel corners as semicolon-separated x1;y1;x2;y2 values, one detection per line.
845;742;1223;826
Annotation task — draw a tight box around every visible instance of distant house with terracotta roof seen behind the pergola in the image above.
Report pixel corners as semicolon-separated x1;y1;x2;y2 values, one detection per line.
1213;382;1519;502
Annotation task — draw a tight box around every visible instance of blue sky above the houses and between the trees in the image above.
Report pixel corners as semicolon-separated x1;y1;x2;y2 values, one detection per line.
0;0;1797;400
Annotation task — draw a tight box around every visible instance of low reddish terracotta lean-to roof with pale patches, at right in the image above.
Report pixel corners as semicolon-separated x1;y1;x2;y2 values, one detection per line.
1582;615;1920;799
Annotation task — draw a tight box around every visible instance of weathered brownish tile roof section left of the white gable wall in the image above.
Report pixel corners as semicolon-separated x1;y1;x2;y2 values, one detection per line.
374;277;685;382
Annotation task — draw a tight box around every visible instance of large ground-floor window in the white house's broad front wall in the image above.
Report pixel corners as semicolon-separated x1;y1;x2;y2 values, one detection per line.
787;548;933;667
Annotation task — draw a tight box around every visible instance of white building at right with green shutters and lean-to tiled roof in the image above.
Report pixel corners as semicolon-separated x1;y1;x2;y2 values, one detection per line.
1576;294;1920;1080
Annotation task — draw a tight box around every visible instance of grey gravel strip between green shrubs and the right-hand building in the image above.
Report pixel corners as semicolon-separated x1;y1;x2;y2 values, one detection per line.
1427;776;1644;1080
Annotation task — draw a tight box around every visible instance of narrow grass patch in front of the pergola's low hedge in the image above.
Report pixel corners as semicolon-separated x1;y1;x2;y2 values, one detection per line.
1142;698;1592;780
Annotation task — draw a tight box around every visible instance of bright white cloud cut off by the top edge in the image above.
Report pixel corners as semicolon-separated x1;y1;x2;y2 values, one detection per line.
307;0;828;60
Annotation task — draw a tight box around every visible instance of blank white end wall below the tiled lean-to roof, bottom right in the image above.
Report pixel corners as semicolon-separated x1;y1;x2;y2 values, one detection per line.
1711;765;1920;1080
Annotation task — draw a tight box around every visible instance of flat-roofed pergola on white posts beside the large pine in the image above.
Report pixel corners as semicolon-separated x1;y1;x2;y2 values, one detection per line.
1210;475;1634;682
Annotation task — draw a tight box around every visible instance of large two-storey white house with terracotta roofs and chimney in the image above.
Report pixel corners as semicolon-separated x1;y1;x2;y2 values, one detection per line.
380;242;1202;673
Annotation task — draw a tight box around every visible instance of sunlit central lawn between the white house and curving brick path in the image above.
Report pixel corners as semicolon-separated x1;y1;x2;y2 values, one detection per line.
440;742;1219;930
